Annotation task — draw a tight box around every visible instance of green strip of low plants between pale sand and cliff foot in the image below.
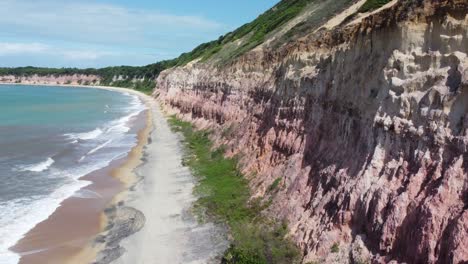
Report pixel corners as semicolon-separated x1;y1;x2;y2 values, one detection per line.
169;116;300;264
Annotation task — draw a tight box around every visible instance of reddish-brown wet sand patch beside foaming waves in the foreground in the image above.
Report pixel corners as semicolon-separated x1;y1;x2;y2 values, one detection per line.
11;159;122;264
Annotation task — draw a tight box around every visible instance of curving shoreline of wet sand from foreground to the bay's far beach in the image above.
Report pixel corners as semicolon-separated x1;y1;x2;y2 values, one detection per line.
0;83;153;264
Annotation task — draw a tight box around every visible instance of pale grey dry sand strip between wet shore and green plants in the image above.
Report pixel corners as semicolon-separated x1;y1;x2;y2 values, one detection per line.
113;101;228;264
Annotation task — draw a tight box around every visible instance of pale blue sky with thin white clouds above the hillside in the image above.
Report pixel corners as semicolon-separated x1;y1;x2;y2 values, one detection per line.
0;0;279;68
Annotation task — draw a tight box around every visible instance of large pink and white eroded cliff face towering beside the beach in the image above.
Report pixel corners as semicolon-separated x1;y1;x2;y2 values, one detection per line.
155;0;468;263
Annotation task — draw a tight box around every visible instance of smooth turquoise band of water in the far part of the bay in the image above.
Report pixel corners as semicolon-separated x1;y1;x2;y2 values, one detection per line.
0;86;120;126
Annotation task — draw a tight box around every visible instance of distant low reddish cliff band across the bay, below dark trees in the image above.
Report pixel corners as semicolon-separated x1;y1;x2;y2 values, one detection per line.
0;74;101;85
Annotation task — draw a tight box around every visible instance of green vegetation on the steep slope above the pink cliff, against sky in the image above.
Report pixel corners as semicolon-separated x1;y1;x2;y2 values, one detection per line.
171;0;356;62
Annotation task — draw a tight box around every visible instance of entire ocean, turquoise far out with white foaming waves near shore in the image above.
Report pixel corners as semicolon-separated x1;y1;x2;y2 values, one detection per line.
0;85;145;264
